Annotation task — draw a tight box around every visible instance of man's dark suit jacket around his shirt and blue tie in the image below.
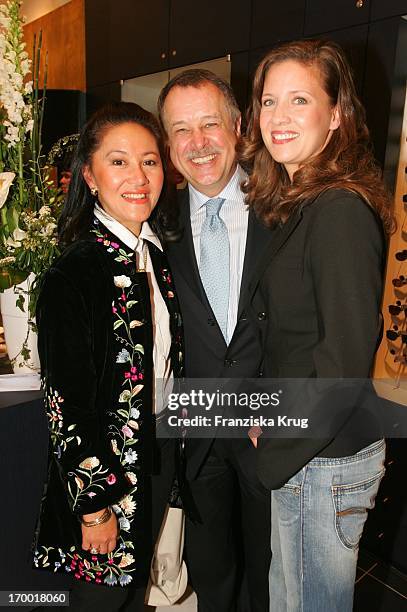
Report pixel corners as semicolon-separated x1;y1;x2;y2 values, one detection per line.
167;188;270;478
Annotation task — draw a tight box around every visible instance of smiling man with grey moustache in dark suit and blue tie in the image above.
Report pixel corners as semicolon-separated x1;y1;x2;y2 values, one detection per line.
158;70;270;612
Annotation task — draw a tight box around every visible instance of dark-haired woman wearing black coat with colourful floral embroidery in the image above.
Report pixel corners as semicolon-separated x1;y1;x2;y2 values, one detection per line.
34;103;182;610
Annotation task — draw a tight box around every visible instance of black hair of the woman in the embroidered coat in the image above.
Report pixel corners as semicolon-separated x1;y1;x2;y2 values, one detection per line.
58;102;178;247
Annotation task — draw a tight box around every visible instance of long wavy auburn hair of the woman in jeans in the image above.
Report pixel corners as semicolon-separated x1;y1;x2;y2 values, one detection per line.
238;40;394;233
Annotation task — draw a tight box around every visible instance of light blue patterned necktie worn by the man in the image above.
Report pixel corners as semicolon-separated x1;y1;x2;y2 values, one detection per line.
199;198;229;343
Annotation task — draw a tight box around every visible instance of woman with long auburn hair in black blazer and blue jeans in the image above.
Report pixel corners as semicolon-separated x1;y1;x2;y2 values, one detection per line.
242;40;393;612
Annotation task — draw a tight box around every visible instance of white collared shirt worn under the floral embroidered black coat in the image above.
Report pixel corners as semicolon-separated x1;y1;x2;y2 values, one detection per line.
94;204;174;414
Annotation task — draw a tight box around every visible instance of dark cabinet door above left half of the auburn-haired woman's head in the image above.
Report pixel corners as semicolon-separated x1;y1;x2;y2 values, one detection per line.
250;0;305;48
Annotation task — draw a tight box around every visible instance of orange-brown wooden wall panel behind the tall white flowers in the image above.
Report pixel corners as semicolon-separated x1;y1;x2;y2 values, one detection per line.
24;0;86;91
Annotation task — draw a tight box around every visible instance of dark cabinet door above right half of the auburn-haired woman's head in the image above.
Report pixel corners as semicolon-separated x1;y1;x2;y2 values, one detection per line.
304;0;371;36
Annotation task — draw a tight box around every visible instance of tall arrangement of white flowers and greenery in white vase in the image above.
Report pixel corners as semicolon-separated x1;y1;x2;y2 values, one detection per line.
0;0;61;358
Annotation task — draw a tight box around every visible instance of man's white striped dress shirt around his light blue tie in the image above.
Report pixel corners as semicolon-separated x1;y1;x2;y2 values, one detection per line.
188;166;249;343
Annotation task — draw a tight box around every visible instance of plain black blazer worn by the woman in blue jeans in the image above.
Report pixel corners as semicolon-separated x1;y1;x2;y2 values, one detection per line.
250;190;385;488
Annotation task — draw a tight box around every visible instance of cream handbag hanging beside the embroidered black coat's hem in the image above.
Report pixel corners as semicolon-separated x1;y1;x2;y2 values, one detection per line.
145;506;188;606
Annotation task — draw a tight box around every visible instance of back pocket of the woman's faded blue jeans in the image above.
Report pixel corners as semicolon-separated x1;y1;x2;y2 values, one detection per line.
331;469;385;549
